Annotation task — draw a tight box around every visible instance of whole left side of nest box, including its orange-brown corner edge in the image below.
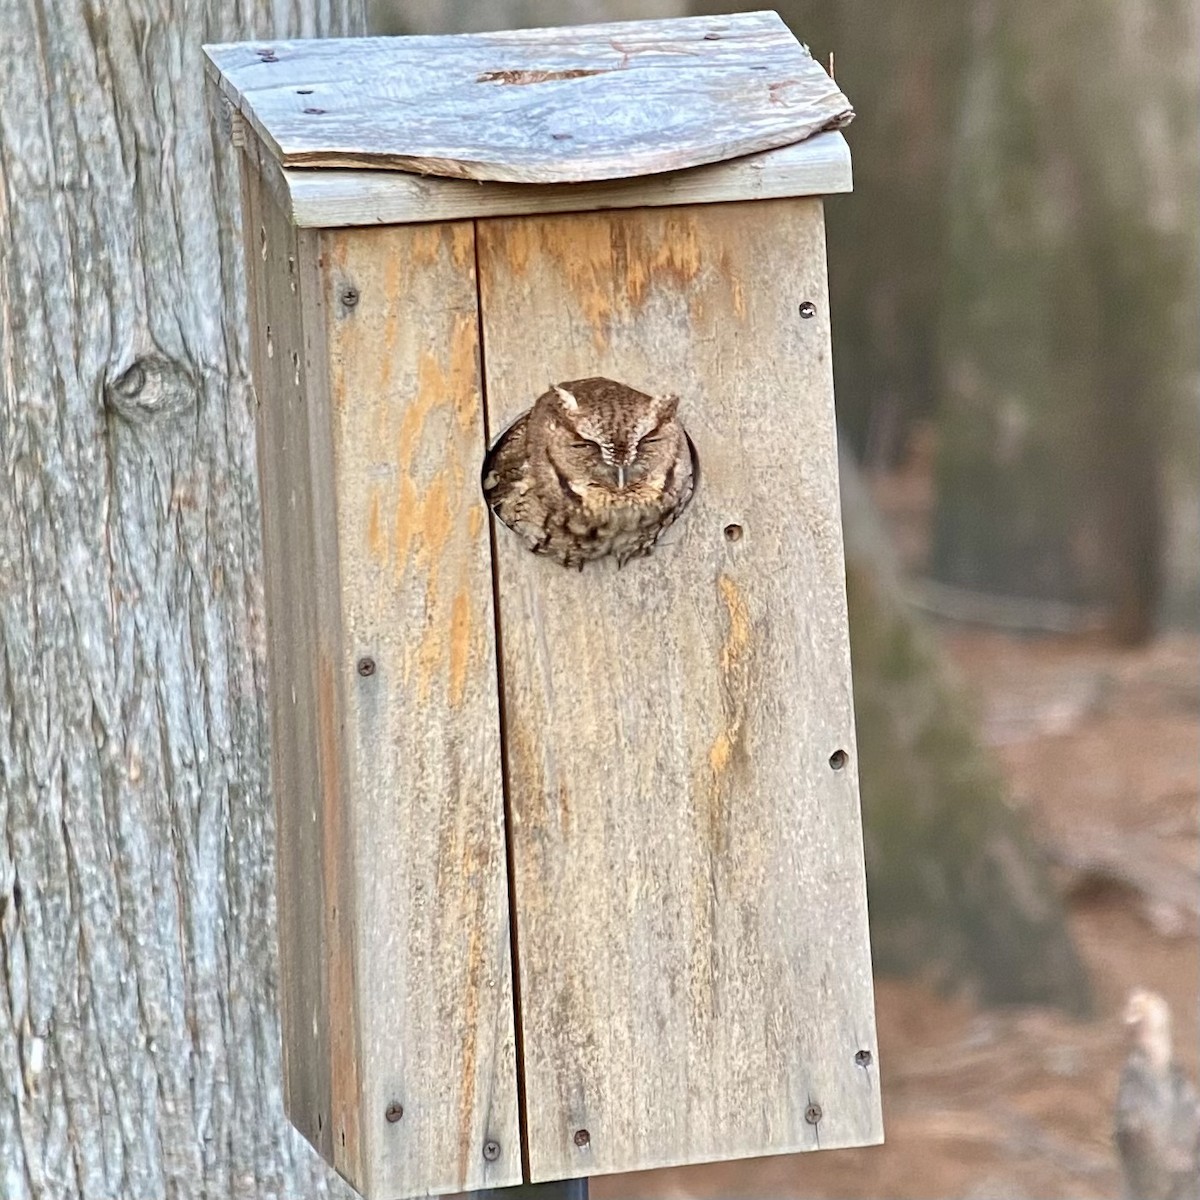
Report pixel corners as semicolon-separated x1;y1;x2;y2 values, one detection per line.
242;163;360;1177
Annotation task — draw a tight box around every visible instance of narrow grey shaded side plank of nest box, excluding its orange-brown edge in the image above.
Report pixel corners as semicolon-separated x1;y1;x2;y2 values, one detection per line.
242;160;335;1162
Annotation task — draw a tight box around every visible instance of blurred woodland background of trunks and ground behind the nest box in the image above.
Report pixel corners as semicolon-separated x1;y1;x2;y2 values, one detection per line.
371;0;1200;1200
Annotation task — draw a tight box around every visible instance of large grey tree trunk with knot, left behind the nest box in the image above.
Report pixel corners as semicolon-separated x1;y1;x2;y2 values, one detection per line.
0;0;356;1200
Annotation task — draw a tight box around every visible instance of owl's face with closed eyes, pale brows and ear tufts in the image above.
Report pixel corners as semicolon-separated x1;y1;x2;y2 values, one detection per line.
538;378;684;500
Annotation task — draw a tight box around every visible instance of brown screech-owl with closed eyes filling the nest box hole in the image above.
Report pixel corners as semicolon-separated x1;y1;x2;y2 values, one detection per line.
484;378;696;569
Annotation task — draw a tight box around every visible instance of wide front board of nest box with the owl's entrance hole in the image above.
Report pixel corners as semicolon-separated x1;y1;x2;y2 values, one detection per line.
476;199;882;1181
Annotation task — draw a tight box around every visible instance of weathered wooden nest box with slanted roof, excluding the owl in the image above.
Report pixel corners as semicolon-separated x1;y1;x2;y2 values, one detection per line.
208;13;882;1200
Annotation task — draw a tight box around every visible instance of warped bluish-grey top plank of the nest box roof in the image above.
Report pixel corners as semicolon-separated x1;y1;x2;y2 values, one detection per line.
205;12;853;184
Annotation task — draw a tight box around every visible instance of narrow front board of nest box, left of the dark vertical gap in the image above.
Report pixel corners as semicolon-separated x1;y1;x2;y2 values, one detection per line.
302;222;521;1200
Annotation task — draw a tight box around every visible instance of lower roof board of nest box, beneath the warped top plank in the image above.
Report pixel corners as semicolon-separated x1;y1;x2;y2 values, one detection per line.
271;132;852;227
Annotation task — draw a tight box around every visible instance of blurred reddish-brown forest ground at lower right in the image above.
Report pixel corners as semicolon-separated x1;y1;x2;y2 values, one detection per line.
592;453;1200;1200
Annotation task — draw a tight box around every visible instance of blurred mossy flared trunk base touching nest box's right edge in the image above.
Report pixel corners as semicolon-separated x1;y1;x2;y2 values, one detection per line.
841;461;1091;1013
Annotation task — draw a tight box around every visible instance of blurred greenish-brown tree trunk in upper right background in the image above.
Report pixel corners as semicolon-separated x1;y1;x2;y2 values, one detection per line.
934;0;1200;642
